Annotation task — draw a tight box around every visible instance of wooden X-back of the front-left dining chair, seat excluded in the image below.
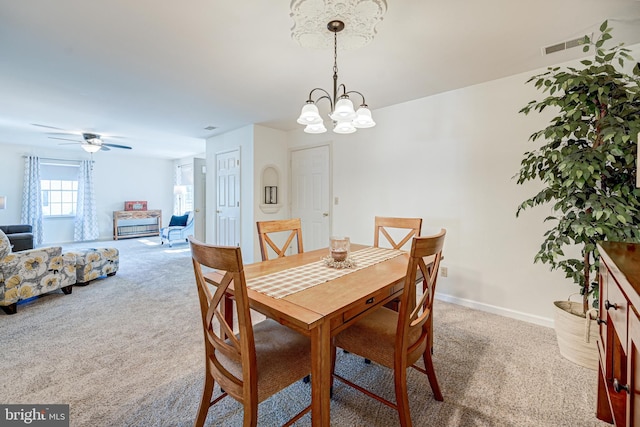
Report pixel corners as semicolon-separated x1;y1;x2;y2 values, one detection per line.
189;236;258;414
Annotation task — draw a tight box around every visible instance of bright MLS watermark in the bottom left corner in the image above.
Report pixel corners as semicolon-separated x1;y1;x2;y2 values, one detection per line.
0;404;69;427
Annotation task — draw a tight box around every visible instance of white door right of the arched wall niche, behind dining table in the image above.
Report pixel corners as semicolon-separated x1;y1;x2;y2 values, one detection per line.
291;145;331;251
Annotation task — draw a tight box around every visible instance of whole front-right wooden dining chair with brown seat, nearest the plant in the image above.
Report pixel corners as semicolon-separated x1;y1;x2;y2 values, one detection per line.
332;229;446;427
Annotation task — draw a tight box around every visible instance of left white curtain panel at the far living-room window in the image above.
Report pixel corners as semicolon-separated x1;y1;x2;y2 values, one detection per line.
21;156;43;245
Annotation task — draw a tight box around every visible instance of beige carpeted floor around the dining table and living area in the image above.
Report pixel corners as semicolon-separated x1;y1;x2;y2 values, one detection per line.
0;238;607;427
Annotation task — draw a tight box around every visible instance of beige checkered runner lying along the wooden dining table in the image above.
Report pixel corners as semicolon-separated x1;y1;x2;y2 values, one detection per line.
247;247;404;298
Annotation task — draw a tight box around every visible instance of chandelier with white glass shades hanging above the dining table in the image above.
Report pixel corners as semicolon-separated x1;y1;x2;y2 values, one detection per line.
297;20;376;134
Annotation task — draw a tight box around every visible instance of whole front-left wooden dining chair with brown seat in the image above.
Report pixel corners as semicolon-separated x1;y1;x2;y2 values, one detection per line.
189;236;311;426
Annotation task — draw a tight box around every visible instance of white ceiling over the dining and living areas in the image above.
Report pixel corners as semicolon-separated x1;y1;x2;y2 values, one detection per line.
0;0;640;158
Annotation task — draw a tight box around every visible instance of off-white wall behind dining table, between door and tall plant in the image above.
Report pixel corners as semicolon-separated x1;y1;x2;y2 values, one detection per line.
289;56;620;326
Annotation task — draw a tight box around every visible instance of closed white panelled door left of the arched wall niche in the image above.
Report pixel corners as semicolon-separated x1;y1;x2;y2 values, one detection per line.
216;149;240;246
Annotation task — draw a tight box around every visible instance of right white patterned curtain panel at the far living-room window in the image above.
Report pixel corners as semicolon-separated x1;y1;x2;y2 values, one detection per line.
73;160;100;242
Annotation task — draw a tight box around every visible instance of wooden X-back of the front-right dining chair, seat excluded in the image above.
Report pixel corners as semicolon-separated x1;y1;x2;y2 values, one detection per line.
395;229;447;369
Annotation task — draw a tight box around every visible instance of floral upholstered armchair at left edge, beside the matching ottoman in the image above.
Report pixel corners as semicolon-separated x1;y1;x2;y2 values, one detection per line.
0;230;76;314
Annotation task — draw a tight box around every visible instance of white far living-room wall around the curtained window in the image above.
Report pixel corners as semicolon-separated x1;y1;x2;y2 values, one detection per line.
0;143;173;244
